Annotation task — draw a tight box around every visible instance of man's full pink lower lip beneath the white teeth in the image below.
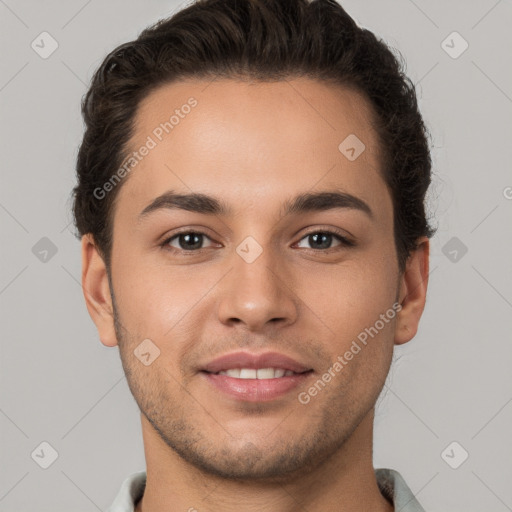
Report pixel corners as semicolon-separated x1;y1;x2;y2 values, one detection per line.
203;371;312;402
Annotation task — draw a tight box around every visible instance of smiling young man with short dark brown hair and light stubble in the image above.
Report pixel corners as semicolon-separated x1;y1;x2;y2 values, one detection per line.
74;0;434;512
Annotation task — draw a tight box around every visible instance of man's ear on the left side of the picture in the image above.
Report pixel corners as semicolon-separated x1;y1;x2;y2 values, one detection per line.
82;233;117;347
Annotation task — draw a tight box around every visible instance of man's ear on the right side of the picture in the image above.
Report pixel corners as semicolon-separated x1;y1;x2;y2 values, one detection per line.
395;237;430;345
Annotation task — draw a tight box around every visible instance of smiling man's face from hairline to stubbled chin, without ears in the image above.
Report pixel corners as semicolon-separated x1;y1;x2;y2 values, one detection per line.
92;80;412;479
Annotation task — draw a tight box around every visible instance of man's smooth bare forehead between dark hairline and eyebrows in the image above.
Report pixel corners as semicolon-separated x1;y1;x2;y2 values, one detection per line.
116;79;389;220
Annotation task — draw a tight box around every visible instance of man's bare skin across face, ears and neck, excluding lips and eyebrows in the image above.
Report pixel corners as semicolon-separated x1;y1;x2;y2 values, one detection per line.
82;79;429;512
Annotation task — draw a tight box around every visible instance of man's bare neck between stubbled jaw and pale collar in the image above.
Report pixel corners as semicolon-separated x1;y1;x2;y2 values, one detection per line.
135;410;393;512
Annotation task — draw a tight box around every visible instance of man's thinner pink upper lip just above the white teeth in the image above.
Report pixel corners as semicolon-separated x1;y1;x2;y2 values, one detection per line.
202;352;311;373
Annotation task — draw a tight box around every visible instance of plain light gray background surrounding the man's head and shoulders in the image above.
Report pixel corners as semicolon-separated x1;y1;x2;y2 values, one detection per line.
0;0;512;512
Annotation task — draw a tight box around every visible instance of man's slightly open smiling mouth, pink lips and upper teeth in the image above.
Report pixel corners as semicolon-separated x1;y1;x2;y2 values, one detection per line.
200;352;314;402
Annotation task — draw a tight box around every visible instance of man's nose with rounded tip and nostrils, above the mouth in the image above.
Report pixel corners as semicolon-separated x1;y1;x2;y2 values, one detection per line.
218;245;299;332
